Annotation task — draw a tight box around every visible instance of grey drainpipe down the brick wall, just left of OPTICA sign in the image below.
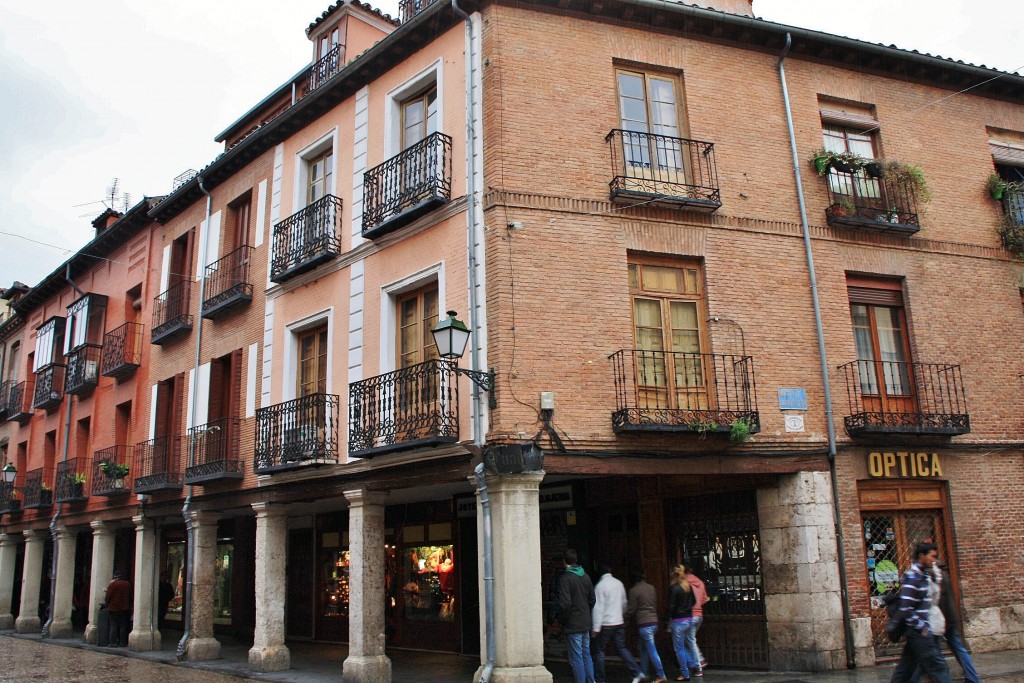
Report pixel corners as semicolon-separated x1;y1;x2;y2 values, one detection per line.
778;33;857;669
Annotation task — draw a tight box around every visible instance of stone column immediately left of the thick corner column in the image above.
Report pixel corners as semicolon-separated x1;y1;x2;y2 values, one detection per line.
341;488;391;683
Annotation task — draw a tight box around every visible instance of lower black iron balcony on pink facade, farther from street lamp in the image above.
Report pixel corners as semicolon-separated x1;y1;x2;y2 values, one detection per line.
253;393;340;474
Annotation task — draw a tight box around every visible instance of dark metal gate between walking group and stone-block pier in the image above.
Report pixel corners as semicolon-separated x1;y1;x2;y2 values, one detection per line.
668;490;768;669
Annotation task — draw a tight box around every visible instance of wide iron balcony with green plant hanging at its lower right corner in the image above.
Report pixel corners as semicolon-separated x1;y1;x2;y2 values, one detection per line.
608;349;761;436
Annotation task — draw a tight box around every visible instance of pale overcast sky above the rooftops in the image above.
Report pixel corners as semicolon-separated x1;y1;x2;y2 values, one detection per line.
0;0;1024;287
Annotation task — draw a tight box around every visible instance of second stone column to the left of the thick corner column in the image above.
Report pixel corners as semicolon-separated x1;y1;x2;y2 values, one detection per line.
249;503;292;673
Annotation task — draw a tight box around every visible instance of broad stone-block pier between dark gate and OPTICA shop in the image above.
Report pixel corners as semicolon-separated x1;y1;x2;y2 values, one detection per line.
758;472;846;671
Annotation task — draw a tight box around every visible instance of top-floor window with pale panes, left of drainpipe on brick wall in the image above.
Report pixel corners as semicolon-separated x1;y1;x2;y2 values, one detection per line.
616;70;683;174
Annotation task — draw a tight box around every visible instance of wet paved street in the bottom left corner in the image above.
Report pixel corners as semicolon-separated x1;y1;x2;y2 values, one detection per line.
0;638;239;683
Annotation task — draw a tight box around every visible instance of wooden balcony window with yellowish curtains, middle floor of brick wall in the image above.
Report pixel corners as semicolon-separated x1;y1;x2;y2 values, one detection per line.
629;261;711;410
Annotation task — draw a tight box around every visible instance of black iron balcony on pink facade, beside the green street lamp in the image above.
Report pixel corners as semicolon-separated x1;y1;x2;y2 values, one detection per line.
348;360;459;458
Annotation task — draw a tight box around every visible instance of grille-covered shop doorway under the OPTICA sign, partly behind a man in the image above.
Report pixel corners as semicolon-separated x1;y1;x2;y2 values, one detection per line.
862;510;948;657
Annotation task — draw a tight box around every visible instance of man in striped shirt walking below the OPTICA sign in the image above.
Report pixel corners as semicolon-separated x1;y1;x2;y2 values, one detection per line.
890;542;952;683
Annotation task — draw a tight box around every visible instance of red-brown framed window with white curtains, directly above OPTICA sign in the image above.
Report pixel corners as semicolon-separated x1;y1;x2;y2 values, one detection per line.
847;279;918;413
